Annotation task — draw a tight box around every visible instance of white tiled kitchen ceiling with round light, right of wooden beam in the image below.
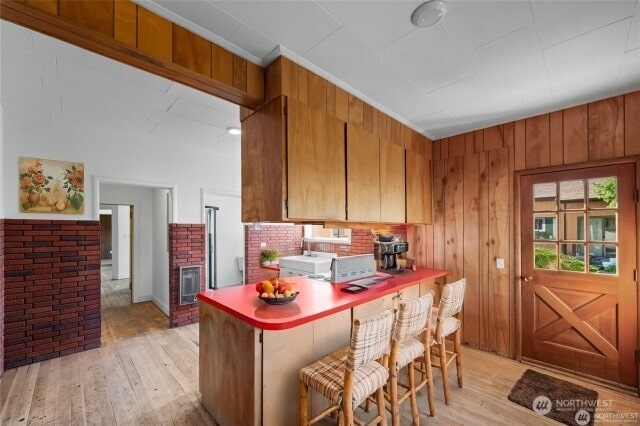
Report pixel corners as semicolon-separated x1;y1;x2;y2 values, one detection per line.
140;0;640;139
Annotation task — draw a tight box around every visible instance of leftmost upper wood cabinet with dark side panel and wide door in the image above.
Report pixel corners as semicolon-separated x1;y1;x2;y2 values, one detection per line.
242;96;346;222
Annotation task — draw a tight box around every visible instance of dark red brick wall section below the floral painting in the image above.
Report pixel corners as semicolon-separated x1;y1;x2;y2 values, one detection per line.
2;219;100;368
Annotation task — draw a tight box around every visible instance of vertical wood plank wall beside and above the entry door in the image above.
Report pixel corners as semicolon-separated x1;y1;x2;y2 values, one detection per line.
407;92;640;356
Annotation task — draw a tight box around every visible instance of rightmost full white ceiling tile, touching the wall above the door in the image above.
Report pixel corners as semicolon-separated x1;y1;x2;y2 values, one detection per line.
544;18;631;104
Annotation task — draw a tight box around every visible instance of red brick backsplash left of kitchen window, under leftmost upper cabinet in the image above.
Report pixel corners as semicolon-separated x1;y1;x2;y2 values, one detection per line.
244;223;303;283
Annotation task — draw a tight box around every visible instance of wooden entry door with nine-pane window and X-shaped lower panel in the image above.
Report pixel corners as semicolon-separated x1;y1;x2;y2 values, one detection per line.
520;163;638;387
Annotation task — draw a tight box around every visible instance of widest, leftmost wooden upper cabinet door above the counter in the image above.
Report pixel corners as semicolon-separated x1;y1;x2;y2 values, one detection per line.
287;99;346;220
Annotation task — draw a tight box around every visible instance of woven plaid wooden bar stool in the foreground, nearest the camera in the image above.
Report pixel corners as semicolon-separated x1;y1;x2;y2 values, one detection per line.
299;309;396;426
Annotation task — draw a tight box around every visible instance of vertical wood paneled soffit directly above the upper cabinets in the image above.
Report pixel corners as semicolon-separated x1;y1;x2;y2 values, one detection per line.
262;56;431;160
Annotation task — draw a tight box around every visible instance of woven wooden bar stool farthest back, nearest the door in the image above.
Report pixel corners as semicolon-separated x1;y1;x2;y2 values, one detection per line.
431;278;467;405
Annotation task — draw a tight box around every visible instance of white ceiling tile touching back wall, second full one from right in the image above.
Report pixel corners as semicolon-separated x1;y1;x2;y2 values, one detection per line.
467;25;552;108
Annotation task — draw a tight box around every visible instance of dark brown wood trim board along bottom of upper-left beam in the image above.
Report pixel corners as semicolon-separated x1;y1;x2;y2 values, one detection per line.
0;0;262;109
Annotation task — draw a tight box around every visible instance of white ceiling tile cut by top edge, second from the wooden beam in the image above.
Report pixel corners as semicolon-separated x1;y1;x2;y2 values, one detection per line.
212;1;340;54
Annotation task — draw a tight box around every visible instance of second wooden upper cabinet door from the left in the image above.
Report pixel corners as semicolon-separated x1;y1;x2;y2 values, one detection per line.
347;125;380;222
